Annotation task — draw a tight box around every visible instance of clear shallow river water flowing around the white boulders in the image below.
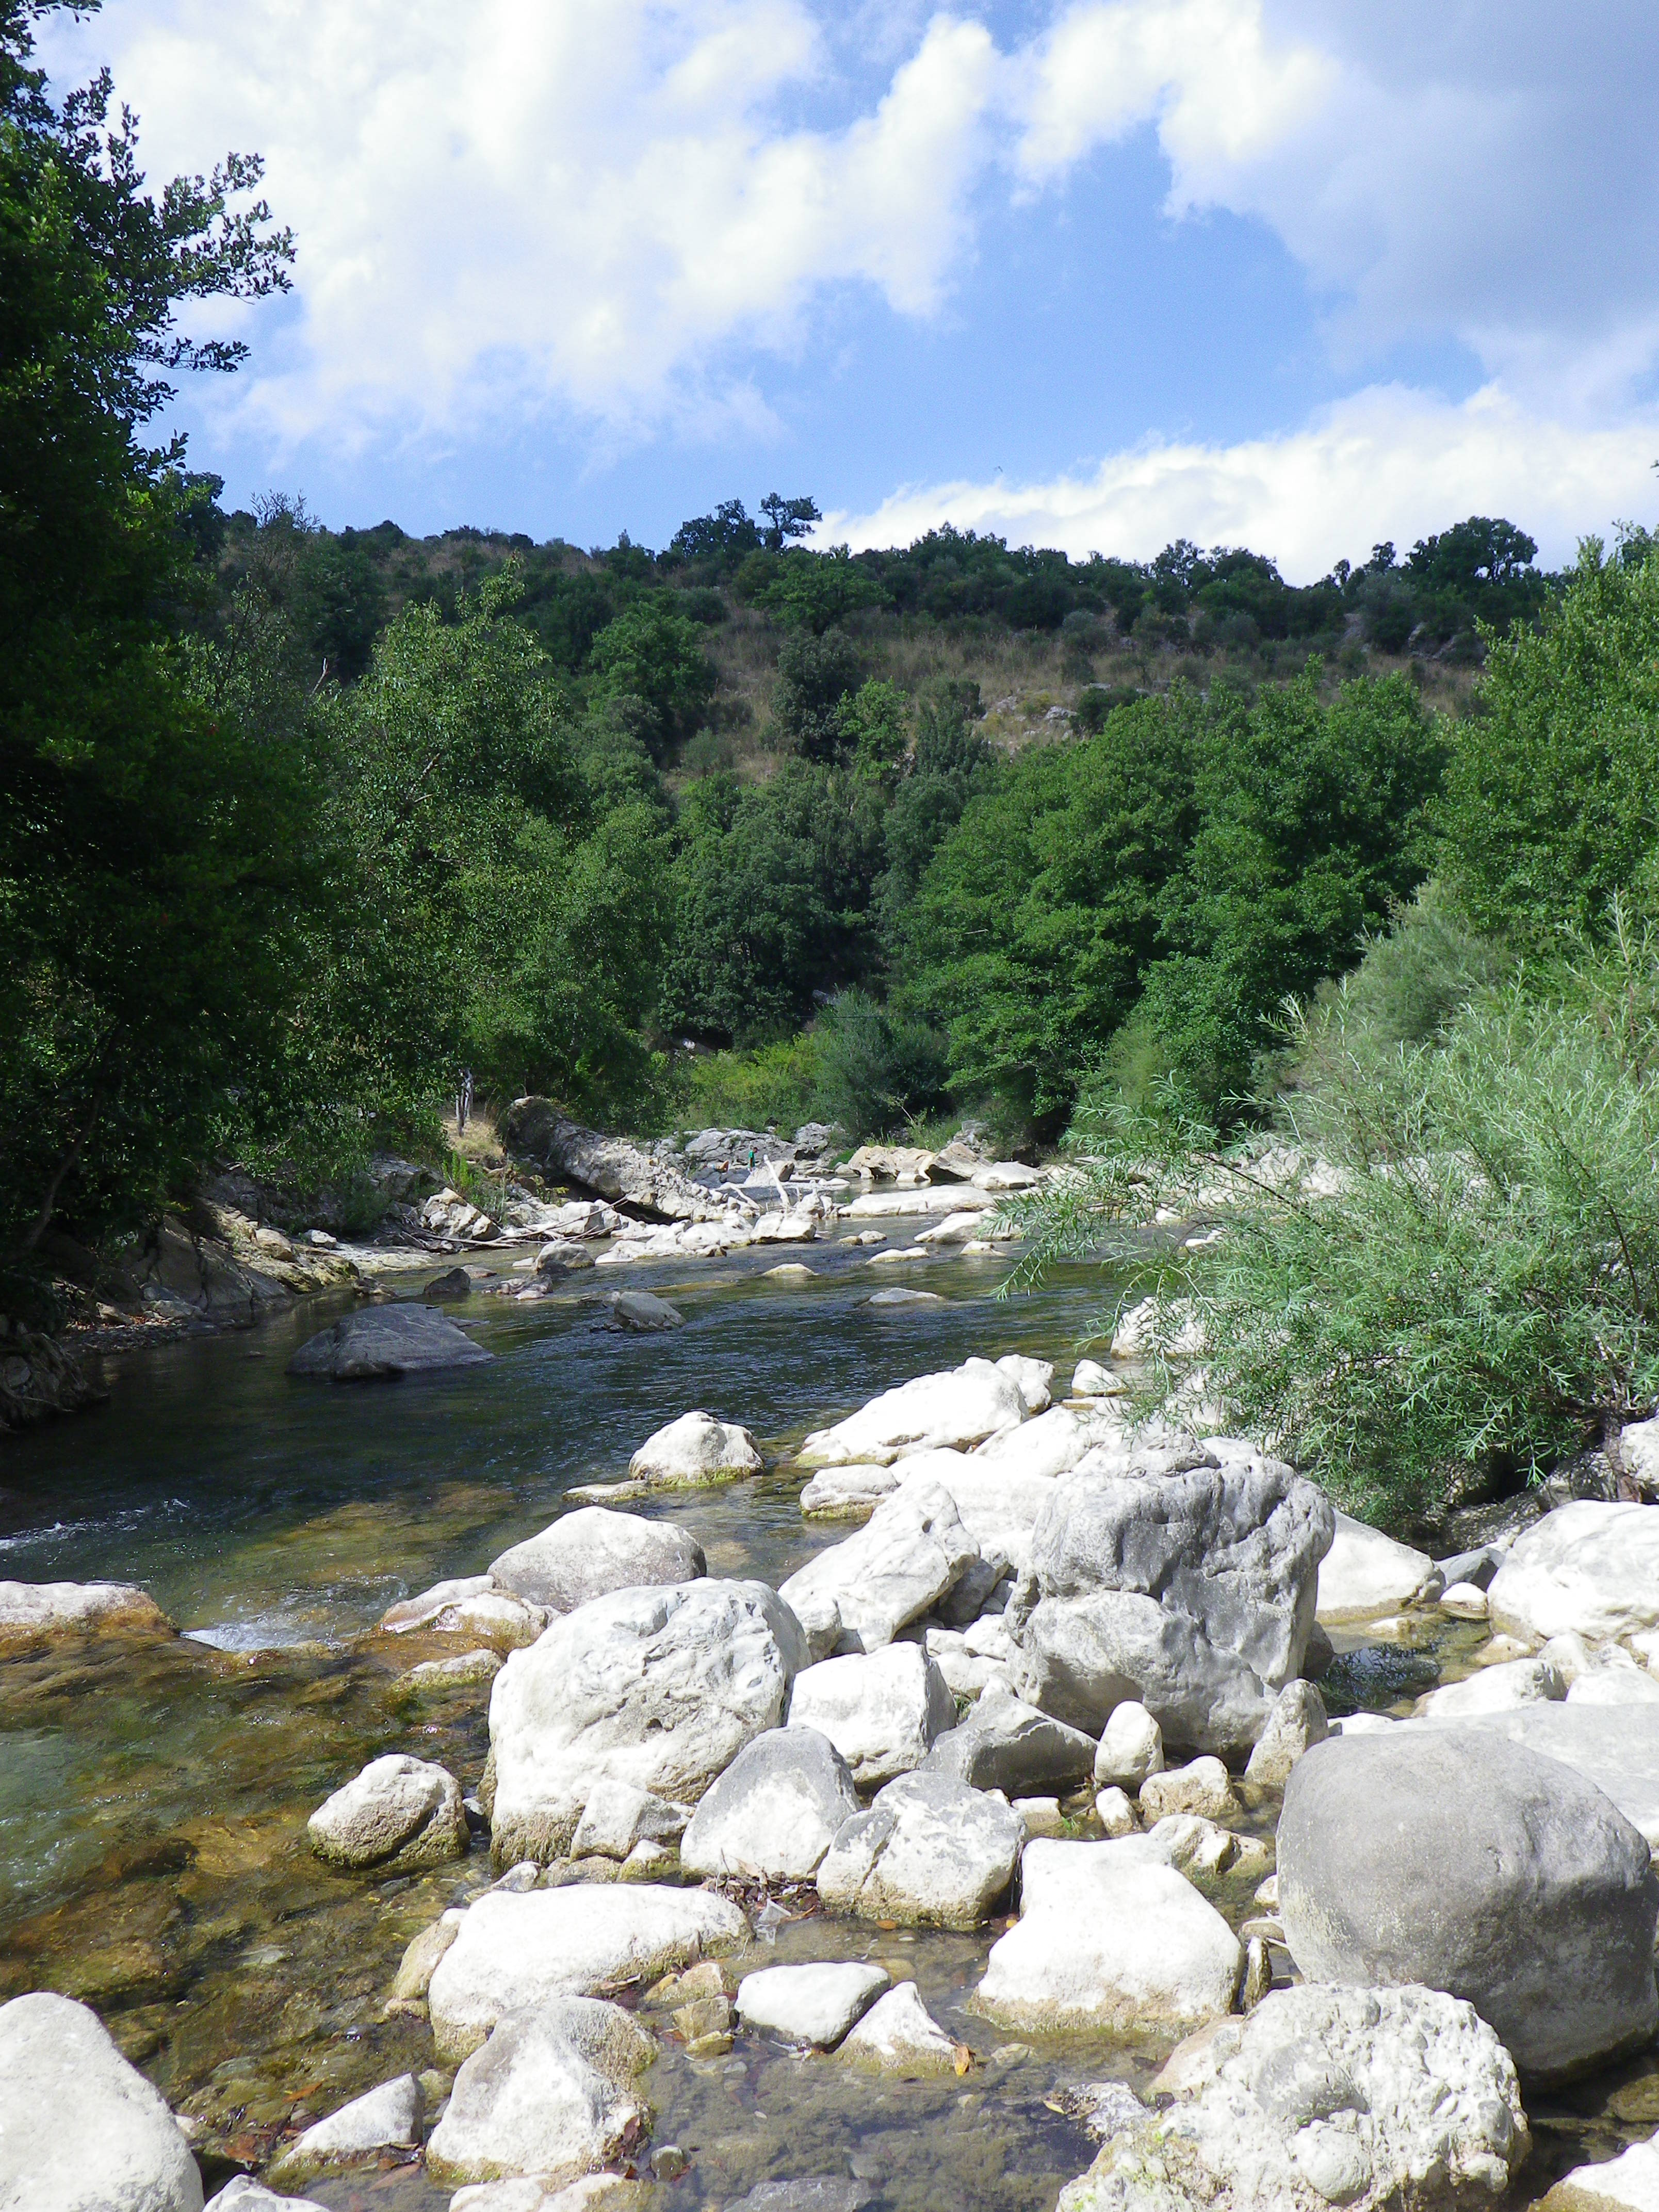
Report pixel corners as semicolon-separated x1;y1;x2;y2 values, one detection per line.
0;1245;1659;2212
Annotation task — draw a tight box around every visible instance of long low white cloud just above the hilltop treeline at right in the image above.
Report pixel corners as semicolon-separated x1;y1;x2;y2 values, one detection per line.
819;385;1659;582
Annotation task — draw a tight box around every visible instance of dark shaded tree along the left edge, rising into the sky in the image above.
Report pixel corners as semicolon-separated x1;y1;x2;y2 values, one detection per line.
0;0;303;1263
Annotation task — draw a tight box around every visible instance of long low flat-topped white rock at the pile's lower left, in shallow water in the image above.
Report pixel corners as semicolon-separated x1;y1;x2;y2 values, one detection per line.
427;1882;750;2061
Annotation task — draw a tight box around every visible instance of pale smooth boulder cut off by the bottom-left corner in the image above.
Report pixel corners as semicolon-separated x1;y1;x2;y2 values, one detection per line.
0;1991;201;2212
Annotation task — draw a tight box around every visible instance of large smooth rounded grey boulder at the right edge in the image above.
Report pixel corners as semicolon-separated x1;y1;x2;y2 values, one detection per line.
1278;1730;1659;2081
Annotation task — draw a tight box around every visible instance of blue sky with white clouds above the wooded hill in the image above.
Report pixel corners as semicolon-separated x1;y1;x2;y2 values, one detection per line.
44;0;1659;577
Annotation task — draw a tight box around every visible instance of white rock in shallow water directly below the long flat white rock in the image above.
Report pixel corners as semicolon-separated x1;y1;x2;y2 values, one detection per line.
427;1997;655;2188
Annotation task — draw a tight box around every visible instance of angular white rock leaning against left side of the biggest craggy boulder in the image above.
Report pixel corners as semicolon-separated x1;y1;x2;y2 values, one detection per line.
778;1482;978;1657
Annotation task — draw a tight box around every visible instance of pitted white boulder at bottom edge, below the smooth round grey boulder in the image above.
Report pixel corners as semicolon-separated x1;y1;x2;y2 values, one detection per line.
1060;1984;1531;2212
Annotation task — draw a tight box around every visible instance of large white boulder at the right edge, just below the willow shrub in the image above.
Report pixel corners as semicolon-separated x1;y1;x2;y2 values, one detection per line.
1487;1498;1659;1644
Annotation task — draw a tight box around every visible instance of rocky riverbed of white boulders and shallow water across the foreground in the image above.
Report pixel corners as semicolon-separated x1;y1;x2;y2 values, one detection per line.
0;1226;1659;2212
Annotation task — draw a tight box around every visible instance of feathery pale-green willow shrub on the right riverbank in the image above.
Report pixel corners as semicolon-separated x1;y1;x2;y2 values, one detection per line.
1011;929;1659;1522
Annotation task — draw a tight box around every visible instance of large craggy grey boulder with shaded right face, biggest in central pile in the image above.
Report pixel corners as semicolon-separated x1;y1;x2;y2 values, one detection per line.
1004;1449;1331;1752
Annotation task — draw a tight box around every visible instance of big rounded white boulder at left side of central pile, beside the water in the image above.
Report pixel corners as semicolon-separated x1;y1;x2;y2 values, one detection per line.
489;1580;807;1865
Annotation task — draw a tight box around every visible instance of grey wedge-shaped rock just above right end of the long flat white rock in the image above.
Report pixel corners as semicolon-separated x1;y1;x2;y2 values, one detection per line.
679;1728;858;1882
